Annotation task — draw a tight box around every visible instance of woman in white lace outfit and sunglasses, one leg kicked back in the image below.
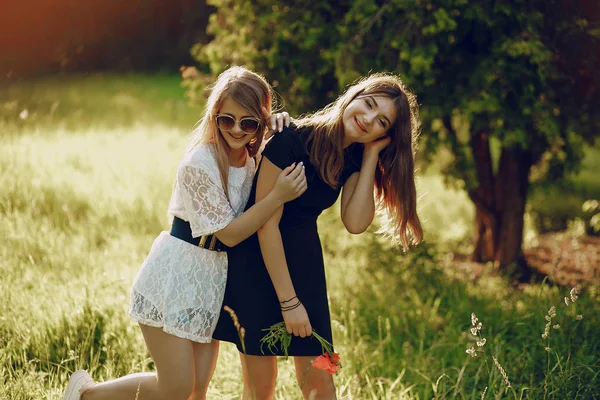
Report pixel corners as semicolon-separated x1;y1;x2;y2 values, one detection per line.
64;67;306;400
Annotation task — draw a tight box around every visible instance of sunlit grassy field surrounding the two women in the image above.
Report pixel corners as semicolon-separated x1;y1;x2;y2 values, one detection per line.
0;75;600;400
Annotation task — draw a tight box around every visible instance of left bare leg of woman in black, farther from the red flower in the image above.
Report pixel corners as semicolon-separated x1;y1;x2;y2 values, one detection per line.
240;353;277;400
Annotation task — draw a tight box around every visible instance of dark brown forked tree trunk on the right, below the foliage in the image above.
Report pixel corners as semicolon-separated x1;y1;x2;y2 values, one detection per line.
469;132;532;267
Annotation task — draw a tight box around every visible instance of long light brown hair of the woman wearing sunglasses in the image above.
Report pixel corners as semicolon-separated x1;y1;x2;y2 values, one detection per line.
188;66;273;202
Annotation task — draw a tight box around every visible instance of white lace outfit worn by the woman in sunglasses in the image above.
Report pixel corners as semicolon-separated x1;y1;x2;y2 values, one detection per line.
129;144;254;343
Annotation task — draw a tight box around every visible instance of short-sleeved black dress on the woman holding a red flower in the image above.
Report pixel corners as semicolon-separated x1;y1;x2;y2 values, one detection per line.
213;126;362;356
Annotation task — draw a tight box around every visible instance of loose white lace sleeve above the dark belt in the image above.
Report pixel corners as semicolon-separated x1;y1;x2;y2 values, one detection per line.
177;165;235;237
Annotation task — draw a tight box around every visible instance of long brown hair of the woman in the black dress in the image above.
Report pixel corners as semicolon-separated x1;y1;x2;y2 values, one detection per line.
295;73;423;250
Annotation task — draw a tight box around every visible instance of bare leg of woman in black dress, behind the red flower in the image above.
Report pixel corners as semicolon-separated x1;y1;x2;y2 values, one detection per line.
294;357;337;400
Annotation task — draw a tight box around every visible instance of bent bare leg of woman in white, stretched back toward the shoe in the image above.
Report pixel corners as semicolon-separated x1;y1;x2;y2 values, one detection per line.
81;324;194;400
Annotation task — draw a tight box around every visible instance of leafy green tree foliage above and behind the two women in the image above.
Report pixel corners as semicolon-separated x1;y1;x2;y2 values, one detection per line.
194;0;600;205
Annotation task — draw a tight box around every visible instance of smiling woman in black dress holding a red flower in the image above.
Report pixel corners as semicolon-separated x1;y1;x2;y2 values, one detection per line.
213;74;422;399
